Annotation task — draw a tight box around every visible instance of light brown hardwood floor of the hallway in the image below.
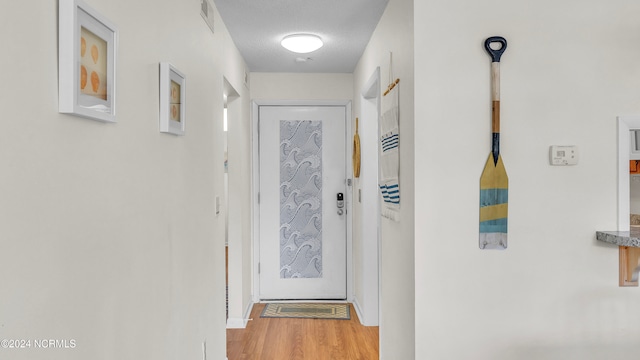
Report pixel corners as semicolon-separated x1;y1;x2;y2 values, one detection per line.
227;304;379;360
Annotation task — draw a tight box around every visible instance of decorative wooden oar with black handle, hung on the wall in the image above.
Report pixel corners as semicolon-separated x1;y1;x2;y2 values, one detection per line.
479;36;509;249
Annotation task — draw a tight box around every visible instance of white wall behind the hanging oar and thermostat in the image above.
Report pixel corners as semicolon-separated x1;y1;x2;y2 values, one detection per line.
415;0;640;360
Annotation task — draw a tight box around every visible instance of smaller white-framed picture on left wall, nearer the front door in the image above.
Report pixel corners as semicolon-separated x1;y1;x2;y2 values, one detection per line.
160;62;186;135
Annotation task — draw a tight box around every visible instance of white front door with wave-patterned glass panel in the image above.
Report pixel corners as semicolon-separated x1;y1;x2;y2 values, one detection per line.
259;106;347;300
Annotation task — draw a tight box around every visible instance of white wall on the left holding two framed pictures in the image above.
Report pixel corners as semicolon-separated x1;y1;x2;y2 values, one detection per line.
0;0;243;360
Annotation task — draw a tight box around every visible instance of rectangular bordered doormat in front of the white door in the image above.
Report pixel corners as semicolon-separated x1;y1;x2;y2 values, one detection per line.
260;303;351;320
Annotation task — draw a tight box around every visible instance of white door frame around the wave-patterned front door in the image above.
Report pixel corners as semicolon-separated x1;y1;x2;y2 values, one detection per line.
251;100;353;303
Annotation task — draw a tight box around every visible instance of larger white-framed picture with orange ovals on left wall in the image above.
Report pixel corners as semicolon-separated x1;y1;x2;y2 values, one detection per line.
58;0;118;122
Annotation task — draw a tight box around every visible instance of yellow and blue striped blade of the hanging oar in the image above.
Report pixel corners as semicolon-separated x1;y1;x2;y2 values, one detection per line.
479;154;509;249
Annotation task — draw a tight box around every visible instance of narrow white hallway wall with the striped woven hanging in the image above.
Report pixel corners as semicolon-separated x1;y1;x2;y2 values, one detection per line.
354;0;421;359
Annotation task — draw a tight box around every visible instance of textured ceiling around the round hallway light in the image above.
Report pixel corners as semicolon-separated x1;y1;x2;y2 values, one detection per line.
214;0;389;73
